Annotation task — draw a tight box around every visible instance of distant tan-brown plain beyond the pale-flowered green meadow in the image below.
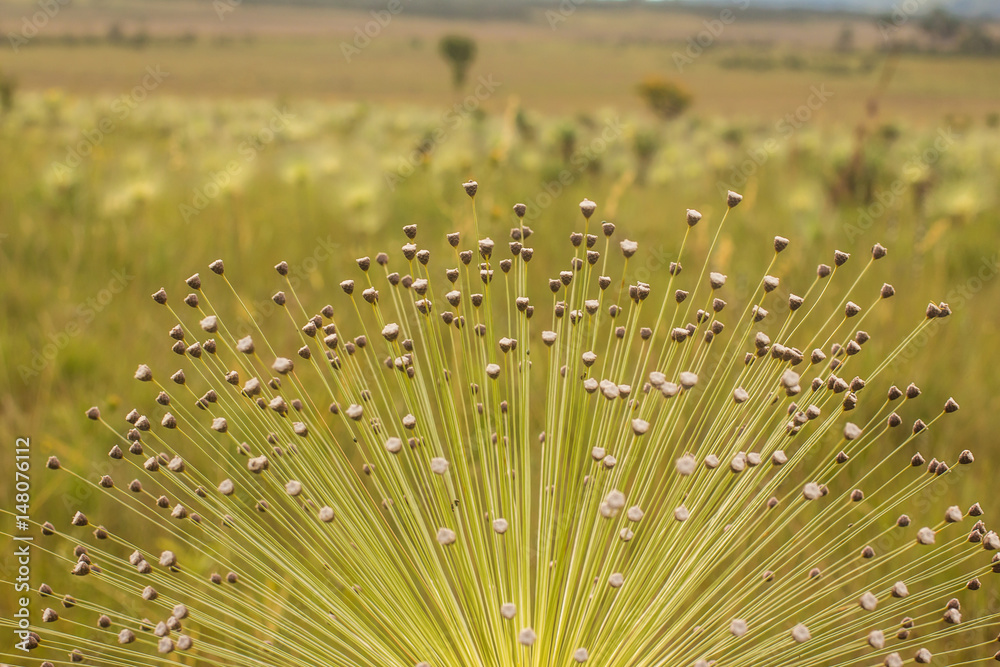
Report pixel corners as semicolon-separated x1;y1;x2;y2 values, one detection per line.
0;0;1000;118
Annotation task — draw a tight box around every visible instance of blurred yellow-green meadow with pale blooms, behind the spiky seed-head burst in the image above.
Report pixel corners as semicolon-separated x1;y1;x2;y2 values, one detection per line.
0;94;1000;490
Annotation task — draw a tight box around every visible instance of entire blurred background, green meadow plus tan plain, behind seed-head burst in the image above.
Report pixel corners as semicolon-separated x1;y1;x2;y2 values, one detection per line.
0;0;1000;620
